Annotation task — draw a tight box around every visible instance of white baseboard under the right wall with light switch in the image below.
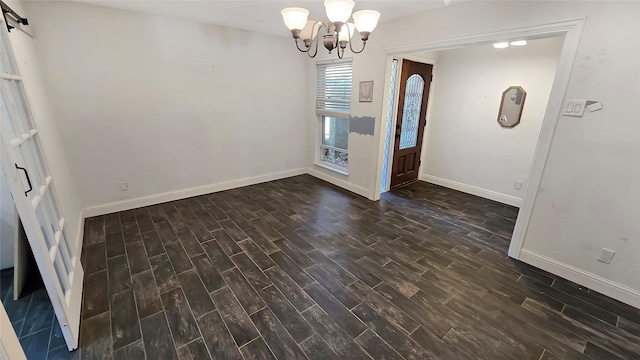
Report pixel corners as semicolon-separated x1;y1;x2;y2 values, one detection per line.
518;249;640;309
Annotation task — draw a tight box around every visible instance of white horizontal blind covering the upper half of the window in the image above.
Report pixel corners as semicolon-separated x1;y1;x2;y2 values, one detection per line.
316;59;352;115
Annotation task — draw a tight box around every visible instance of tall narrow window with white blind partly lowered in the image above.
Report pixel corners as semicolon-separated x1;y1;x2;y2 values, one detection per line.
316;59;352;168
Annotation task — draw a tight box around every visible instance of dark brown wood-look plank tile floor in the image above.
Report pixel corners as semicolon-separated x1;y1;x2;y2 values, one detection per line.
76;176;640;360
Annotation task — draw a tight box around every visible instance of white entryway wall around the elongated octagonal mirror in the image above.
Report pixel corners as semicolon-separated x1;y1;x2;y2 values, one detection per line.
420;38;562;205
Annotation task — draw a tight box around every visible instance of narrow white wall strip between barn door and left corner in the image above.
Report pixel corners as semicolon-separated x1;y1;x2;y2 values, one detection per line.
2;1;83;250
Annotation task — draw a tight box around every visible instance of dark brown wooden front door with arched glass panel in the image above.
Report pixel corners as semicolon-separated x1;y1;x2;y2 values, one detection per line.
391;60;433;188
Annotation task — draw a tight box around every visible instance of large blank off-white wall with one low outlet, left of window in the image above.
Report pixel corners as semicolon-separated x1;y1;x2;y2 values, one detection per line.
22;2;306;213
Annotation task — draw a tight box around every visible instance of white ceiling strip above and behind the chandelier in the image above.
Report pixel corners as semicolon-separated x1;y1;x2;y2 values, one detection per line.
70;0;448;36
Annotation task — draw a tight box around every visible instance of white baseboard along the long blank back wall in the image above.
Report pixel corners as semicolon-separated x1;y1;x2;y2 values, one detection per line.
83;168;307;218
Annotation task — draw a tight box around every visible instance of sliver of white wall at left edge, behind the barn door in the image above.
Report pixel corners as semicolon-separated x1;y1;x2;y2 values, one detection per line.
0;169;15;270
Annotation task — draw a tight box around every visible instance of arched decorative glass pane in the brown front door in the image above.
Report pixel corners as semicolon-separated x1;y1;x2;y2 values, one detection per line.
400;74;424;150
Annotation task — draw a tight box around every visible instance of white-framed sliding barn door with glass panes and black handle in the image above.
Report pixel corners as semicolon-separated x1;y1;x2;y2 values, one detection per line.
0;18;84;350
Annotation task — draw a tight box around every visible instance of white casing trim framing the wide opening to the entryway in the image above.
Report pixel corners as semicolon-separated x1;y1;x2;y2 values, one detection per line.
369;17;587;259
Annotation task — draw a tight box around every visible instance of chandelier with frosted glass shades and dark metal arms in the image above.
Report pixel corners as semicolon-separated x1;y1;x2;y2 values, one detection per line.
281;0;380;59
